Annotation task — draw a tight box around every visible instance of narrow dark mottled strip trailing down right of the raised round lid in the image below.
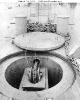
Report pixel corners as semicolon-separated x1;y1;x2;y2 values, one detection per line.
64;33;80;73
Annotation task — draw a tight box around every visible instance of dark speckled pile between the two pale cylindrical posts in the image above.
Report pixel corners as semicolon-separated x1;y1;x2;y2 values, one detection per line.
27;20;56;33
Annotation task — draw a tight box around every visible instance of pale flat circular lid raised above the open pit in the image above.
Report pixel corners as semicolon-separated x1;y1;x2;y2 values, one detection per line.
14;32;65;51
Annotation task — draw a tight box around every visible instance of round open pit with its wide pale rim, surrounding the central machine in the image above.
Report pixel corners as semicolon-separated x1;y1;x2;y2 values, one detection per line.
0;51;76;100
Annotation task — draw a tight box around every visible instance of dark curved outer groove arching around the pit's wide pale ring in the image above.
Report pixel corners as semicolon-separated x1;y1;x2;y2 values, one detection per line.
0;51;76;99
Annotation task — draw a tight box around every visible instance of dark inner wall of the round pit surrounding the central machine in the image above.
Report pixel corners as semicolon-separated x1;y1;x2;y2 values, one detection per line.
5;56;63;89
